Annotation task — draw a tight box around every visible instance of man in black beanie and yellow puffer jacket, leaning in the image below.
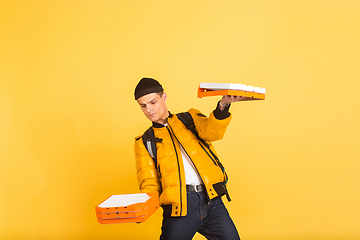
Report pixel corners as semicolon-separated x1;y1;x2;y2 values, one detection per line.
135;78;242;240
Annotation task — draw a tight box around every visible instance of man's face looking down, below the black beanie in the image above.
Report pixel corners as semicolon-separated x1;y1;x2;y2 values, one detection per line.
137;93;169;124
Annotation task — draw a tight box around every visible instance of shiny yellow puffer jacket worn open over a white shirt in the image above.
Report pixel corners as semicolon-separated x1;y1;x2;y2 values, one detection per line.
135;108;231;217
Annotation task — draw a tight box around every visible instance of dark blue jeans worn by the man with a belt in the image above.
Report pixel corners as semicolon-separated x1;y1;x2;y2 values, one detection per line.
160;192;240;240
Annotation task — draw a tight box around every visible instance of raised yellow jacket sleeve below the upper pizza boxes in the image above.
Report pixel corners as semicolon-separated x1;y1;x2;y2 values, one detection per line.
188;105;231;142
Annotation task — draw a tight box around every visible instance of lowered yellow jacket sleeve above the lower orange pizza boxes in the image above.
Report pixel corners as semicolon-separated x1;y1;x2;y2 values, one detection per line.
134;137;161;195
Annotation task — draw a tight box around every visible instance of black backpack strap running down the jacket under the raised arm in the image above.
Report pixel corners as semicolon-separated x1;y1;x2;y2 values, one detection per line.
176;112;231;202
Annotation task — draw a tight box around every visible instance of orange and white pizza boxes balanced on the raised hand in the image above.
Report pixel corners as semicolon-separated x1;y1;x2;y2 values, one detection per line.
198;83;265;101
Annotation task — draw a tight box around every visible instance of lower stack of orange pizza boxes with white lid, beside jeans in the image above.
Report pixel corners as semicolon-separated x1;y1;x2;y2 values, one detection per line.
95;193;159;224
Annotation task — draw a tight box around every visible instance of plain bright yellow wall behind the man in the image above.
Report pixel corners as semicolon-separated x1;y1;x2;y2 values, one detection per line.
0;0;360;240
